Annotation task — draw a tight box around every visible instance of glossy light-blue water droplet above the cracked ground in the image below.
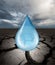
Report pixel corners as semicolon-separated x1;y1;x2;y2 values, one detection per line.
15;16;39;51
